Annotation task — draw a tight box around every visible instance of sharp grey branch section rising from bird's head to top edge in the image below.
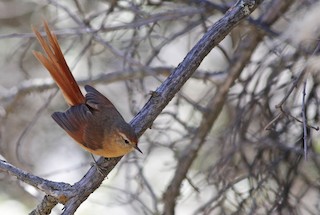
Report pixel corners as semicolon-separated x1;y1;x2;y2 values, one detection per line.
132;0;262;135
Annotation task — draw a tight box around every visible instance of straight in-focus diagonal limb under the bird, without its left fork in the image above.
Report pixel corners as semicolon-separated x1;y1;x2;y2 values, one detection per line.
63;0;262;214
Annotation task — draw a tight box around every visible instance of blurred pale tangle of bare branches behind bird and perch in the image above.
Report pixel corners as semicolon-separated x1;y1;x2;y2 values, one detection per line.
0;0;320;215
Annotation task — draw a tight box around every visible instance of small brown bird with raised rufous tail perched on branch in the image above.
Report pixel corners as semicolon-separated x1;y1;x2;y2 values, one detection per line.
32;21;142;158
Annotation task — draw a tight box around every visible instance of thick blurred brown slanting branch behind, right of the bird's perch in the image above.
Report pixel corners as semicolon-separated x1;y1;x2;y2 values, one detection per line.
163;0;296;215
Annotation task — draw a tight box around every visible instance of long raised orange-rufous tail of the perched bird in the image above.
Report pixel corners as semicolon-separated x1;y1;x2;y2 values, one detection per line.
32;21;85;106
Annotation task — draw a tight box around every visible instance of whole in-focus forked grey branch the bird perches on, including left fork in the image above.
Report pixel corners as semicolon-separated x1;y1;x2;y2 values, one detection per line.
0;0;262;214
